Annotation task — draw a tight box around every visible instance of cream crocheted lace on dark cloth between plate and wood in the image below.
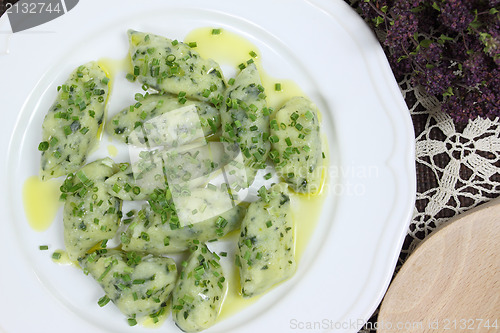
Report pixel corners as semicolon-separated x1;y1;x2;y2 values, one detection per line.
360;79;500;333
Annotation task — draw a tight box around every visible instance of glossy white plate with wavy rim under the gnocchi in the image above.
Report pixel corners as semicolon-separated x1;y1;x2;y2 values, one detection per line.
0;0;415;333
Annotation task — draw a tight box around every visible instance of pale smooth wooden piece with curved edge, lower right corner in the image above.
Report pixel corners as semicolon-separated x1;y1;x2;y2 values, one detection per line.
376;198;500;333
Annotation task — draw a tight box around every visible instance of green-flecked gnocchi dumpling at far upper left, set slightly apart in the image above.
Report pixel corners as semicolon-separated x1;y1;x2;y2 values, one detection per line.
38;61;109;180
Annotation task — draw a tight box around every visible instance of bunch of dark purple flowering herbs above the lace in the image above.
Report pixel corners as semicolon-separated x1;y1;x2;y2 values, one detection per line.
346;0;500;123
